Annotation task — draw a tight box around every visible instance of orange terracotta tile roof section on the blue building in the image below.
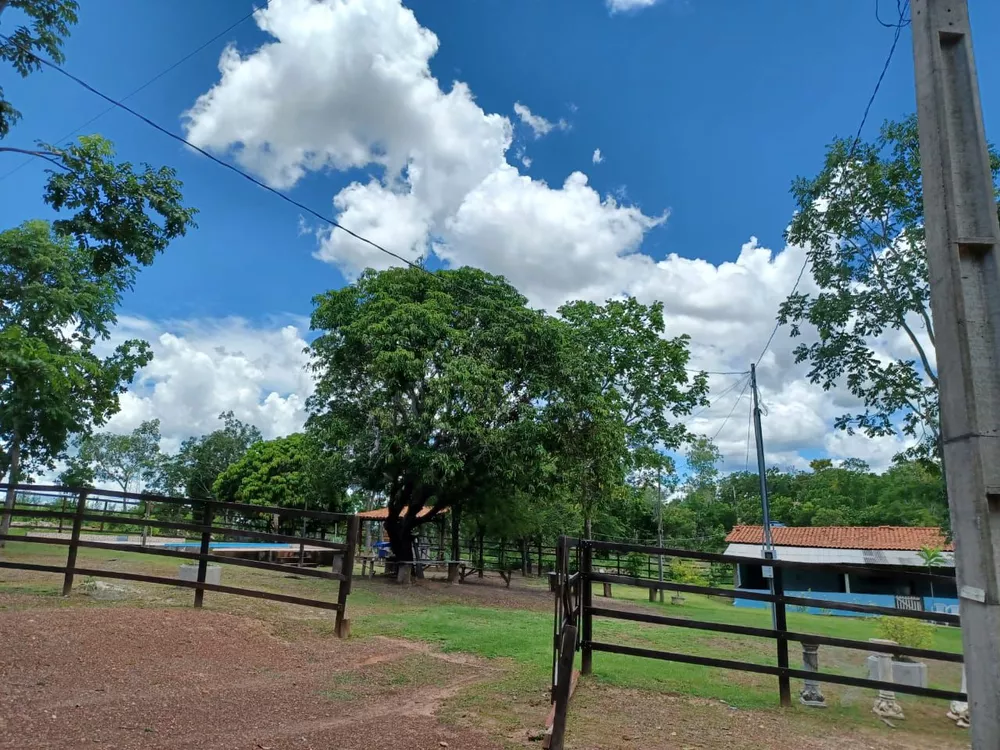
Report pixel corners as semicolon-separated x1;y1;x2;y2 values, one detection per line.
726;526;955;552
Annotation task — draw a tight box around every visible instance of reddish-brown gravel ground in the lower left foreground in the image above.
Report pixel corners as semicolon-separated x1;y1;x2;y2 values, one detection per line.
0;607;502;750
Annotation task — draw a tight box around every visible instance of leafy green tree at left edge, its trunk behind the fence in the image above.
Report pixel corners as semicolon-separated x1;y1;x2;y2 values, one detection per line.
0;221;151;544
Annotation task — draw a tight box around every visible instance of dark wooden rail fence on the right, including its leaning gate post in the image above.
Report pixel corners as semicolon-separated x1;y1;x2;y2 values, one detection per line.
549;537;968;750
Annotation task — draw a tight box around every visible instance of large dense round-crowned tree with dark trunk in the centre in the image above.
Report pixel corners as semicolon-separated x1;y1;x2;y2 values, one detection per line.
307;268;556;560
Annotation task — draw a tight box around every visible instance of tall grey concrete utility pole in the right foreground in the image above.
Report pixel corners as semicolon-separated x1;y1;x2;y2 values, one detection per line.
911;0;1000;750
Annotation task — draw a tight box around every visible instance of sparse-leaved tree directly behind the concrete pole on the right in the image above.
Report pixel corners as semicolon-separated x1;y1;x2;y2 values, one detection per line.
779;116;1000;462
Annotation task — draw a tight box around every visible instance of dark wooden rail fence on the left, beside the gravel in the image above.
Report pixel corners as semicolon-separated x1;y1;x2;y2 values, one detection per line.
0;484;358;638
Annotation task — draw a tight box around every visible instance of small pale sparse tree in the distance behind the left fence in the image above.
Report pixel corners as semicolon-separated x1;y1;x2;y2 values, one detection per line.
78;419;160;492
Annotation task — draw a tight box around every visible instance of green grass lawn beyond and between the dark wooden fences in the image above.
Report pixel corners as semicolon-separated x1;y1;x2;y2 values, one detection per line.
0;542;961;748
